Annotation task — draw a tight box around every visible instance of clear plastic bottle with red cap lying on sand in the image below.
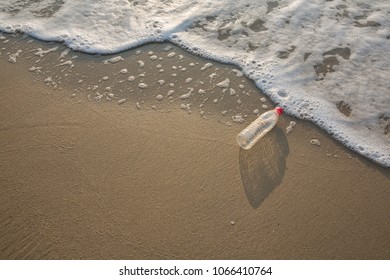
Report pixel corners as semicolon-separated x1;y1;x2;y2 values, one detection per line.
237;107;283;150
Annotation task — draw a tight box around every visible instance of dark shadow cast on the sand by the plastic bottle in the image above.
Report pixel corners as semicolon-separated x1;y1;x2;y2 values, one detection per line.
239;127;289;208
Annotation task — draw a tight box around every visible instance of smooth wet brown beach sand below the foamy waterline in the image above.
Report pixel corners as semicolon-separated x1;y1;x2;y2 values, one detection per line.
0;36;390;259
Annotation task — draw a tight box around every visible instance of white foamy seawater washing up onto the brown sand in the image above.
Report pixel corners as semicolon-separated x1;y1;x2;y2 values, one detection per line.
0;0;390;167
